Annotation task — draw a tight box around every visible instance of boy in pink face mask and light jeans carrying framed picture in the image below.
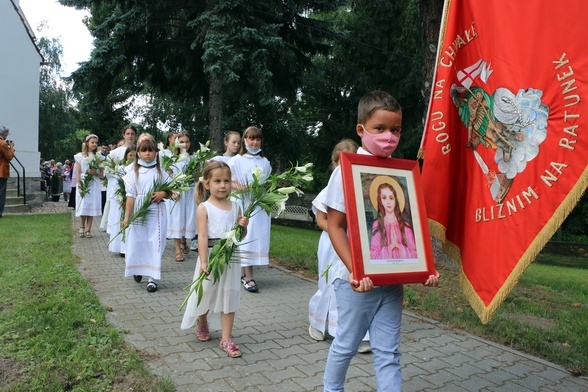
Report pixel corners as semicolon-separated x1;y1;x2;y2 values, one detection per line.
323;91;439;391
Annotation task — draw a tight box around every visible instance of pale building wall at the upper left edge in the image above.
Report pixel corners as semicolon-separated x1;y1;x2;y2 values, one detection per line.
0;0;43;183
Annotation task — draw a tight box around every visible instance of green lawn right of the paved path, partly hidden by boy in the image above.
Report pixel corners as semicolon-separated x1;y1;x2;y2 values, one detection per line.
270;225;588;375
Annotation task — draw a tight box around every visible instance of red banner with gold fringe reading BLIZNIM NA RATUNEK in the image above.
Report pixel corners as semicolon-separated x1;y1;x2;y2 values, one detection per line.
422;0;588;323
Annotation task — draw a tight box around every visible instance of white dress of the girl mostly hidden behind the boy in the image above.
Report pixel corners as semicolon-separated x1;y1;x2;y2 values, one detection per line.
308;188;337;336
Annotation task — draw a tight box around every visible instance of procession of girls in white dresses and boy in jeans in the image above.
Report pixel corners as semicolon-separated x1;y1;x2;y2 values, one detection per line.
72;91;439;391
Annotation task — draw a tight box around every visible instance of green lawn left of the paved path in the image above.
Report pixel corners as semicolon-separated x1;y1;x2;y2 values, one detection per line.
0;214;174;392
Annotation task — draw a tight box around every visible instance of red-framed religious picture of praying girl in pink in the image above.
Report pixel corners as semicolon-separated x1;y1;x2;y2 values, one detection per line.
340;153;435;286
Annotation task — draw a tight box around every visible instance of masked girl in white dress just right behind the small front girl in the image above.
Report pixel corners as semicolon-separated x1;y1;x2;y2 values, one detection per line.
229;126;272;293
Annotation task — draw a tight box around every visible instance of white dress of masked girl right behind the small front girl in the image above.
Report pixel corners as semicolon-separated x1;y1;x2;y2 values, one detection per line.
229;154;272;267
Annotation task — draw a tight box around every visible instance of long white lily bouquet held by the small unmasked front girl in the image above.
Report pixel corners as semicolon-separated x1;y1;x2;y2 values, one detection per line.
180;163;313;310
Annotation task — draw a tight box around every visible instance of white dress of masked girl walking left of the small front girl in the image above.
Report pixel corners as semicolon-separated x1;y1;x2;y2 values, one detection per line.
123;167;171;279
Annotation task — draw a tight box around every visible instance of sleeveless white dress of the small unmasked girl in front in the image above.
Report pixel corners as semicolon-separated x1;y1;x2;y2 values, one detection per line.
180;201;241;329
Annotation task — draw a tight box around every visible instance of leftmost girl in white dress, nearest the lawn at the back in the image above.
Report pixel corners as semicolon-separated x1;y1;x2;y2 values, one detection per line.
74;134;104;238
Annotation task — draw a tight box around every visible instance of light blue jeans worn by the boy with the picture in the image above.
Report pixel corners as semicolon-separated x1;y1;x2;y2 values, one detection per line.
323;279;404;392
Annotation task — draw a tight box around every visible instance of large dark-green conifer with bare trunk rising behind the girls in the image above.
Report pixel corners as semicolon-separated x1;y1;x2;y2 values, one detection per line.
60;0;338;149
